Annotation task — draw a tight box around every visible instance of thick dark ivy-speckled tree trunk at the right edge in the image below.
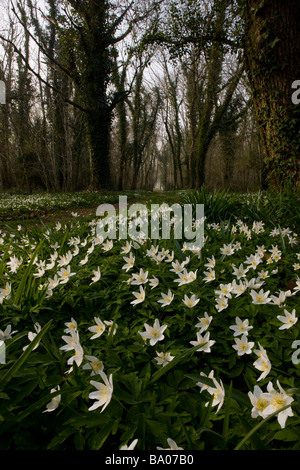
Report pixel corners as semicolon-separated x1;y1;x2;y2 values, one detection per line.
245;0;300;188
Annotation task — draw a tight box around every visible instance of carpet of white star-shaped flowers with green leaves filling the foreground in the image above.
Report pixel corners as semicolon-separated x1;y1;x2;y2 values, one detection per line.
0;204;300;450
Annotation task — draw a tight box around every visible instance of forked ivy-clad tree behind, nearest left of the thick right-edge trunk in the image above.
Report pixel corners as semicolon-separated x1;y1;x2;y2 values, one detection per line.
144;0;244;188
